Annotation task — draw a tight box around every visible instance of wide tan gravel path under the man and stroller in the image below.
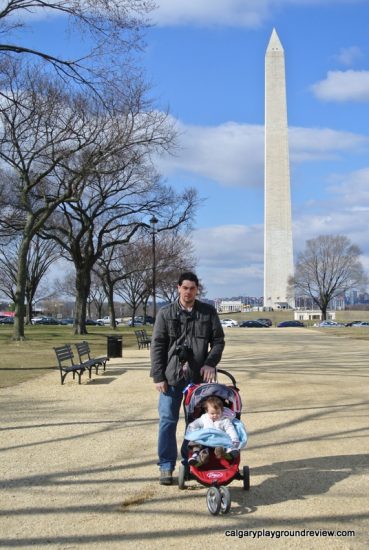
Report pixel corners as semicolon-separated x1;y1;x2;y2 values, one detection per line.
0;329;369;550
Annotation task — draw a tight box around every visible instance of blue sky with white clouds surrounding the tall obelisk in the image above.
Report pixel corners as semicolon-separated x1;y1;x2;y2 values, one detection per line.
8;0;369;298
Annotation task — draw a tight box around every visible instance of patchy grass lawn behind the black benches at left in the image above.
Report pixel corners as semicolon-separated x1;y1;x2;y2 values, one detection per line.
0;325;150;387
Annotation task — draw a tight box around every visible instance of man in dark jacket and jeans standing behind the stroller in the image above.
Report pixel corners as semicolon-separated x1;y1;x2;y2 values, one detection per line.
150;272;224;485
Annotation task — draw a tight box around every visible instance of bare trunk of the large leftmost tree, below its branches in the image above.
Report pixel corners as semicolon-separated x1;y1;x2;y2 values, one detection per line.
13;237;31;340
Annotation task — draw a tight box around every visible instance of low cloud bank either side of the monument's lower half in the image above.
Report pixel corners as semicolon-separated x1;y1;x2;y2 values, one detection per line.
192;168;369;298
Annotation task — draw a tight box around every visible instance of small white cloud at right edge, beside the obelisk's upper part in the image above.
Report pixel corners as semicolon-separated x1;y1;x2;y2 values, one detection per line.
311;70;369;102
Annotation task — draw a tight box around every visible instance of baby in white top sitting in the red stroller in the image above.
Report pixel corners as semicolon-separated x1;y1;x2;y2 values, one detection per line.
186;396;240;467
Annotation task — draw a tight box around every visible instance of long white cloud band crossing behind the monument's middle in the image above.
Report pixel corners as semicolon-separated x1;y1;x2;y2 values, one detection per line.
157;122;369;187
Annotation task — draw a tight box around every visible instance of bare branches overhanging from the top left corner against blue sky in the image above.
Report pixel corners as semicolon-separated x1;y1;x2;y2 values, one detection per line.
0;0;155;98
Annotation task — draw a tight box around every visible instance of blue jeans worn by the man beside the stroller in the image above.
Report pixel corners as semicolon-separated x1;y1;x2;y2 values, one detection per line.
158;380;188;470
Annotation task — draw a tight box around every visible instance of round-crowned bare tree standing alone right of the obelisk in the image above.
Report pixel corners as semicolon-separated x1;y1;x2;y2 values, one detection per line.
289;235;368;319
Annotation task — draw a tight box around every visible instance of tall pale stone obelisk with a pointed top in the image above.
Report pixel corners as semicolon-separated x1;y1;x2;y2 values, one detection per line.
264;29;294;309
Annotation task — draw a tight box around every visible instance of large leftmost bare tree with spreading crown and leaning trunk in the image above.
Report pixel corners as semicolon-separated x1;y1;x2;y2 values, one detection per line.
0;63;115;339
